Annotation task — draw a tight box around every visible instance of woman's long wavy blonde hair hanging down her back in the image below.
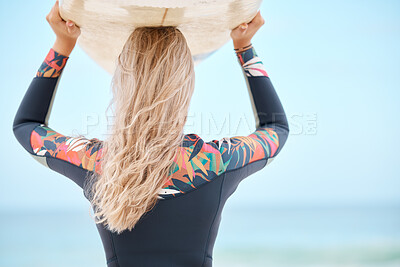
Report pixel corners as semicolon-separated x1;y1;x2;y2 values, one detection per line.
88;26;195;233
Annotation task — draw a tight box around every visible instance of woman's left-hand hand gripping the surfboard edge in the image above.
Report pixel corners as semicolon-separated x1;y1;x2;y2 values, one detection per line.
46;0;81;56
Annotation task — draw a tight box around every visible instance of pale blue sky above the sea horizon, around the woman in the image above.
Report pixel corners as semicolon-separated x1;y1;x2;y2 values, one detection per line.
0;0;400;209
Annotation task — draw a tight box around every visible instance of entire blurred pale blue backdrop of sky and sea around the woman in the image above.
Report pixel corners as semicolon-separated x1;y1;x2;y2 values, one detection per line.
0;0;400;267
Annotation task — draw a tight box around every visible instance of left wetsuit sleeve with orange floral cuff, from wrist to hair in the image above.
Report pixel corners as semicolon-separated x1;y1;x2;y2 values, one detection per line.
13;48;101;188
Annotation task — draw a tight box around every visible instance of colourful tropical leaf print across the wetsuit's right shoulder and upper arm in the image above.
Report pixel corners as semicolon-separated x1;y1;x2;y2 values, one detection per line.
160;128;279;198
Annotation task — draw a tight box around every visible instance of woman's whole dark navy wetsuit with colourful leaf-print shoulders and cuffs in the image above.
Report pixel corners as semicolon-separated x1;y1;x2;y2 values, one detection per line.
13;45;289;267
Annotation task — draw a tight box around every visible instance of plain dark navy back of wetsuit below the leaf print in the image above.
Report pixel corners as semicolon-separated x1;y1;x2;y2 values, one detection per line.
98;158;265;266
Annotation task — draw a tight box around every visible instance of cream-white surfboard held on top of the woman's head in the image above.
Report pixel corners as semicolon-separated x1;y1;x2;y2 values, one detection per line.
60;0;262;74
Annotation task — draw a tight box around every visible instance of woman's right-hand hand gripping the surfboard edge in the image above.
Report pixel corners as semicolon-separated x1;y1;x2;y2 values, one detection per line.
231;11;265;49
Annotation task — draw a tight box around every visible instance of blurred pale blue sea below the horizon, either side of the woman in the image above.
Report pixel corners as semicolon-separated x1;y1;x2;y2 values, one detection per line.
0;206;400;267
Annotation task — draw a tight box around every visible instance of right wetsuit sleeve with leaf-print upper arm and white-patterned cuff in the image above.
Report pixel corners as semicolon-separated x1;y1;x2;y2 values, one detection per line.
211;47;289;171
